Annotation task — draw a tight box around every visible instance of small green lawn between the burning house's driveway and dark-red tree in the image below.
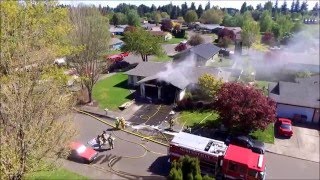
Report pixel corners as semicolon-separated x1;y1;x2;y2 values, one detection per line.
178;111;219;126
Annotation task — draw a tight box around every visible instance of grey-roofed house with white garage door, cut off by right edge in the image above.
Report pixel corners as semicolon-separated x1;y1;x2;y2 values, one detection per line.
269;75;320;124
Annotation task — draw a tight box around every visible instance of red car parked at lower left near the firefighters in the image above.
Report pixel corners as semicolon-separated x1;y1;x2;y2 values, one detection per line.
69;142;98;164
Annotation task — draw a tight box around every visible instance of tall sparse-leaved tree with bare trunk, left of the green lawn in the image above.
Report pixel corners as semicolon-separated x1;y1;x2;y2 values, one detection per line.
68;6;110;102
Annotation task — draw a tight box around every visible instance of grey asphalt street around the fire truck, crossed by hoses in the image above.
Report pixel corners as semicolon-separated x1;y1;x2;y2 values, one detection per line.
65;113;320;179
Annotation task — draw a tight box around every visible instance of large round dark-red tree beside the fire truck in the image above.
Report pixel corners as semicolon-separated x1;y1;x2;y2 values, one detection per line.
215;82;276;134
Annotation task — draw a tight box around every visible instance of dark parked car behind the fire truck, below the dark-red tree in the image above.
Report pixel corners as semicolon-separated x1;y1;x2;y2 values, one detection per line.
226;136;265;154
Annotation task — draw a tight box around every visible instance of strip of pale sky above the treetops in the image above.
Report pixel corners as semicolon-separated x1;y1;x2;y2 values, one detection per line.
59;0;318;10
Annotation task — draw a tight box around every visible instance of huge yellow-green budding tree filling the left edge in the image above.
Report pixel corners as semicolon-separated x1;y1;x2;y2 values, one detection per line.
0;1;75;179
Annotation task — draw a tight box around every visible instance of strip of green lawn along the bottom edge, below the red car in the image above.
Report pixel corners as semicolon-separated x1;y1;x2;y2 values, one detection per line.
25;169;88;180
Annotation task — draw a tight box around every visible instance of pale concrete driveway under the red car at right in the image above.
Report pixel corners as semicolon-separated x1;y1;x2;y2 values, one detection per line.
266;126;319;162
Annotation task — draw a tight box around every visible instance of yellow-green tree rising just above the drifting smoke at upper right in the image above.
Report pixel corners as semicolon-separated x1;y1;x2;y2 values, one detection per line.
241;19;260;48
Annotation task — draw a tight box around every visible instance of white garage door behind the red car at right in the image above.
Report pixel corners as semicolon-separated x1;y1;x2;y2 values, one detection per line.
277;104;314;122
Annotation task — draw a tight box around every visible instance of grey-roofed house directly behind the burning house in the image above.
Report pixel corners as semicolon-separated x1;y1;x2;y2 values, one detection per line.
173;43;221;66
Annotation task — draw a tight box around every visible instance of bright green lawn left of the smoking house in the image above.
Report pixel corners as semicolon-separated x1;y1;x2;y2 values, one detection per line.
93;73;132;110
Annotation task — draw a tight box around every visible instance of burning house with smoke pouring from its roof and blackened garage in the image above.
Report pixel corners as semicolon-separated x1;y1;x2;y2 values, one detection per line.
125;62;231;103
